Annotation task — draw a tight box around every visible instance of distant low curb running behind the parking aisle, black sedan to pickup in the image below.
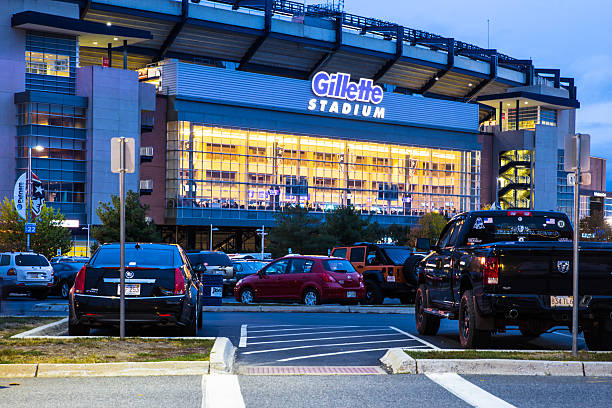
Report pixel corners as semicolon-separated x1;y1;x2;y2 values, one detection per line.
202;305;414;314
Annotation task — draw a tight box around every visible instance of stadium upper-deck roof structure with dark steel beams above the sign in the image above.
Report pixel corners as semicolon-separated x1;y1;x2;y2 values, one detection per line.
60;0;576;105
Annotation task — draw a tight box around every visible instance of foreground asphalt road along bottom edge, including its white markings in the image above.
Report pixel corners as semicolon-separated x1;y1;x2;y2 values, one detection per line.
0;374;612;408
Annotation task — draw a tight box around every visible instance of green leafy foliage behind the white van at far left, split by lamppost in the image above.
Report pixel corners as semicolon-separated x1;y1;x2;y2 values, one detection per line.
0;198;72;258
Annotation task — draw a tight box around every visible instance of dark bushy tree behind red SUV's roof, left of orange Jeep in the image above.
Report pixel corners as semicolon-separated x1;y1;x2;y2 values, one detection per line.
268;206;333;258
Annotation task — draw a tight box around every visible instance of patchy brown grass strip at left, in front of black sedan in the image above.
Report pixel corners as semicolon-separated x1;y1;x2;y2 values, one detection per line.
0;337;214;364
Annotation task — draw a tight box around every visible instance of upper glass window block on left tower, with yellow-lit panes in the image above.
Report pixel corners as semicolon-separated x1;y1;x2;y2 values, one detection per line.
25;31;78;95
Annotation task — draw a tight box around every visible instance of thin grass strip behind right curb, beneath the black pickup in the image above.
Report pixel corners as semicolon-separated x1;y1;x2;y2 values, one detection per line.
405;350;612;361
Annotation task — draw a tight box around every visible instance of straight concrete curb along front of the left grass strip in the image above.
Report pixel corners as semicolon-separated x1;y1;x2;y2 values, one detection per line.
0;361;210;378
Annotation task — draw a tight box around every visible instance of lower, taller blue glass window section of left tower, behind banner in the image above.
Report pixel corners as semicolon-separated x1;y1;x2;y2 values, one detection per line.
17;102;87;222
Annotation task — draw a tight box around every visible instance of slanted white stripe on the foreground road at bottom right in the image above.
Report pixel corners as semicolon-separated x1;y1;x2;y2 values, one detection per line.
426;373;515;408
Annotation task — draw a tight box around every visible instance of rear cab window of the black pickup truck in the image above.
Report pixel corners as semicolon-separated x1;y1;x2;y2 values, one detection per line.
464;212;572;245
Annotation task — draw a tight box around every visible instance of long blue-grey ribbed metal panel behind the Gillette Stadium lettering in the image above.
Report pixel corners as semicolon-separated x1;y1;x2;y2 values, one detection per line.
170;62;478;132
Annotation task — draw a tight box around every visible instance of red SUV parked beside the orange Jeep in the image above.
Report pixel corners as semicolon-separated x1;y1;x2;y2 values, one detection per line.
234;255;366;305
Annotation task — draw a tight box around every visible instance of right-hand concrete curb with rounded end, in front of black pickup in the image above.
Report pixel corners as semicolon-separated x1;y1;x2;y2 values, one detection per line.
380;348;612;377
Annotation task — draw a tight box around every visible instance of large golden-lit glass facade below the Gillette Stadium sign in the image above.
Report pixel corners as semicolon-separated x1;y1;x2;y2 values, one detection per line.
166;121;480;222
